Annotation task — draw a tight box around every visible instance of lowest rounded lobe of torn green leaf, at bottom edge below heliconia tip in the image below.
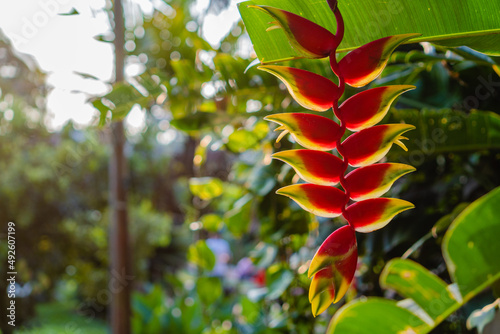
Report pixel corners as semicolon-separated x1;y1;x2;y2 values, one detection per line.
326;298;430;334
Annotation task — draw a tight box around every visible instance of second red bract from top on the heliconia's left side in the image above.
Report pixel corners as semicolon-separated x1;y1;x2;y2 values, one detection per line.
257;65;338;111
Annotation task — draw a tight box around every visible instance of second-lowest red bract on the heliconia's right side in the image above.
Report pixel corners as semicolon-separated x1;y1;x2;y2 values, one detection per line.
345;163;415;201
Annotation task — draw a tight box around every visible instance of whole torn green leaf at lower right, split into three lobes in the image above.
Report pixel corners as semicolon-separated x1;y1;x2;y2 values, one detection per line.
328;188;500;333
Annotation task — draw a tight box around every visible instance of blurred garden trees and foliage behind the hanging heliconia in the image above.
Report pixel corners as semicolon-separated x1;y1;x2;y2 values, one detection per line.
0;0;500;334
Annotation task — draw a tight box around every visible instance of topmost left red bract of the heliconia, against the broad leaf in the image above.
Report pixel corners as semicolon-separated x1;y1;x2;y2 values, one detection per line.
248;5;340;58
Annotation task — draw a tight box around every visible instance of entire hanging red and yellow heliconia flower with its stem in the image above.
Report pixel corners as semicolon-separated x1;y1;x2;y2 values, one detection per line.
247;0;418;316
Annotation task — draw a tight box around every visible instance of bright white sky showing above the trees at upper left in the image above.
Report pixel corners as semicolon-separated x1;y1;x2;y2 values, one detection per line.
0;0;241;130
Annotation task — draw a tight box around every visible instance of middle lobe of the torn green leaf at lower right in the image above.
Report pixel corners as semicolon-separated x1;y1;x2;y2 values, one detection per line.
380;259;458;322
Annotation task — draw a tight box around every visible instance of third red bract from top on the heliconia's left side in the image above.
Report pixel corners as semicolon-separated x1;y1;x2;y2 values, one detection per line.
264;113;341;151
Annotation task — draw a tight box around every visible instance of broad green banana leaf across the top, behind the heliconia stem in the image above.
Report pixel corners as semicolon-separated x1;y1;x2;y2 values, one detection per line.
239;0;500;63
